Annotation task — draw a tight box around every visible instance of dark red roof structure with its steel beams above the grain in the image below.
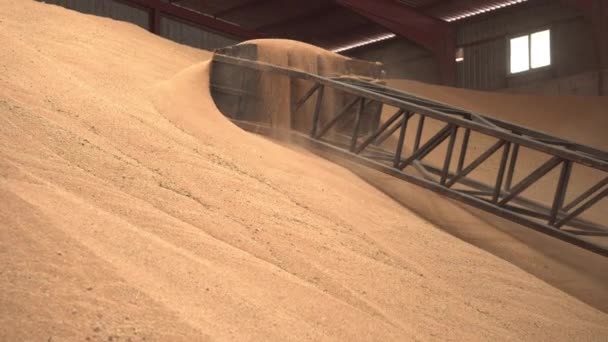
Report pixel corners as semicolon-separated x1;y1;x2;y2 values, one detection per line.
118;0;592;85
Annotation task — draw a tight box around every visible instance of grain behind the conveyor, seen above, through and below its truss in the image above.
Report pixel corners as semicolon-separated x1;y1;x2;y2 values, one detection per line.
354;80;608;312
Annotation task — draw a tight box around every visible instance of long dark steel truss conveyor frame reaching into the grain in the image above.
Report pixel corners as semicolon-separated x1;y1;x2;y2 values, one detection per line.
213;54;608;256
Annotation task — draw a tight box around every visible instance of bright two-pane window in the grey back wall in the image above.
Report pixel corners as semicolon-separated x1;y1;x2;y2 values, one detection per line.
510;30;551;74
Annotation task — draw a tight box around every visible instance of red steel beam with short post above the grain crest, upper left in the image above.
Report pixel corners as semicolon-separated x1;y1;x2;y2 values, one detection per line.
119;0;261;40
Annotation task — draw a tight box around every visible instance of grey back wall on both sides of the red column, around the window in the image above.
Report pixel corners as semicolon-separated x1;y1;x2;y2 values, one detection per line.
348;0;608;95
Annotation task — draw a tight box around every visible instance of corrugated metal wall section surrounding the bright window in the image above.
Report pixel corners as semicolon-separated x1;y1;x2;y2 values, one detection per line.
457;0;596;90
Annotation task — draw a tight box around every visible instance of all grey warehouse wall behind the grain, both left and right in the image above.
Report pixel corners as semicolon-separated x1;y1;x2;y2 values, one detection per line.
38;0;608;95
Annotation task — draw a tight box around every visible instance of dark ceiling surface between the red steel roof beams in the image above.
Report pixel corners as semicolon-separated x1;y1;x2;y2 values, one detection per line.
169;0;522;50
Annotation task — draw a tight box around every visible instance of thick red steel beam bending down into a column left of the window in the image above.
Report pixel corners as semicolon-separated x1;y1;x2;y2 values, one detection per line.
336;0;456;85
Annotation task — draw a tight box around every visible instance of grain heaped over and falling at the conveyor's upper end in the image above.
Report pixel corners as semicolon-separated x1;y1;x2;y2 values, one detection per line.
233;39;380;132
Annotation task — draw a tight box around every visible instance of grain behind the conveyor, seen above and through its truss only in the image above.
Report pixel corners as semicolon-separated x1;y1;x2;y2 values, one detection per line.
387;80;608;227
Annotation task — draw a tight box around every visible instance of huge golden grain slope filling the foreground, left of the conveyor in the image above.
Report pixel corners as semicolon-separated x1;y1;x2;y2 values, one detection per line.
0;0;608;341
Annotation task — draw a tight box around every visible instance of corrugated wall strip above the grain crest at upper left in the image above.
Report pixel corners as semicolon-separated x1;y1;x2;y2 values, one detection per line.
36;0;239;50
